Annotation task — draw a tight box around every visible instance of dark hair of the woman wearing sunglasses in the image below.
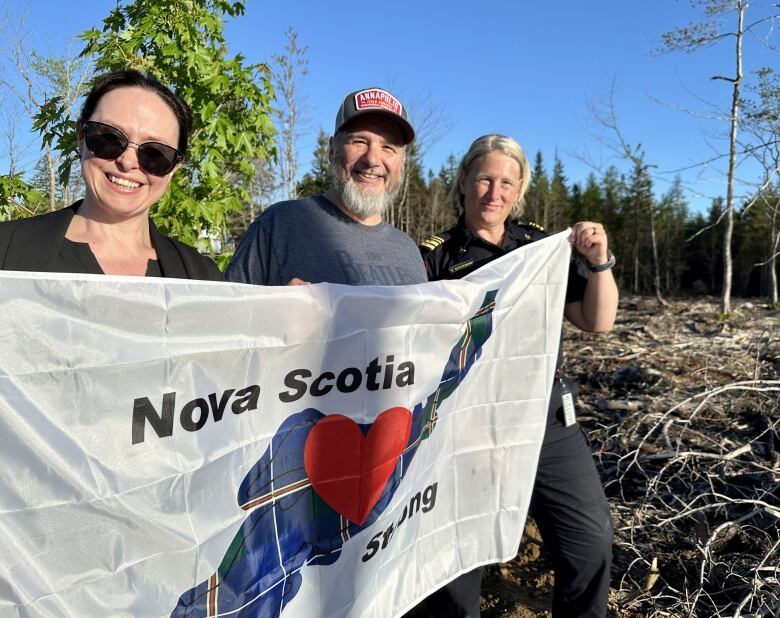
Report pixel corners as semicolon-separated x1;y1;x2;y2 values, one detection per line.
79;69;192;156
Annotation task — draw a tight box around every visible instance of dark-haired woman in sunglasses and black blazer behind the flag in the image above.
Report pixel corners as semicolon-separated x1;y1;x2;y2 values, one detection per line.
0;70;222;281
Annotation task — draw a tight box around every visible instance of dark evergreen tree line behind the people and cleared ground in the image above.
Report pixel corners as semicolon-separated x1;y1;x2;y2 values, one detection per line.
290;131;780;302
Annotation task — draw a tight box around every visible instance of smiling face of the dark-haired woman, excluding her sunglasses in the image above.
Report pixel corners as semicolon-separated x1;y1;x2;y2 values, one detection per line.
79;86;179;221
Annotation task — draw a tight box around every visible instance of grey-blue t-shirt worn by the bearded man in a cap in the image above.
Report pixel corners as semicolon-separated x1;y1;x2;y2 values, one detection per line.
225;195;428;285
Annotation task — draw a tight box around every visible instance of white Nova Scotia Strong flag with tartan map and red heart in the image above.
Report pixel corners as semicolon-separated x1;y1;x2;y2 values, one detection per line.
0;233;569;618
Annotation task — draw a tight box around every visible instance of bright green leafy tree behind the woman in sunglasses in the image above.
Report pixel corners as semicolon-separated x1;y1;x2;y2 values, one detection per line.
36;0;274;255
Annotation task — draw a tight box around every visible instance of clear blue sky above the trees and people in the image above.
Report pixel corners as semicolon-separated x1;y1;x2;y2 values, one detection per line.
6;0;780;210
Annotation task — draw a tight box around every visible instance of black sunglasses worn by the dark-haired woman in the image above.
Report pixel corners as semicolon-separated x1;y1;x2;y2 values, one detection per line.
82;120;182;176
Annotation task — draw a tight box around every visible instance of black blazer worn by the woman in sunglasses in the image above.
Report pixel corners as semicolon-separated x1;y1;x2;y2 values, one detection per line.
0;200;222;281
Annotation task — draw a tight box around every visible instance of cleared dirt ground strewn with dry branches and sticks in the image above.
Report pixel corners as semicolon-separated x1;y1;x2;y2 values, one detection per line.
482;298;780;618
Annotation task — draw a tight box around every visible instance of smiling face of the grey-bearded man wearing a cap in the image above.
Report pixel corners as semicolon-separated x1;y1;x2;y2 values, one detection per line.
330;115;404;220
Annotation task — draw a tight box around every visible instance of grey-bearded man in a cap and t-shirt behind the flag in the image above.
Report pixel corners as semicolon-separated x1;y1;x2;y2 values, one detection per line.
225;88;427;285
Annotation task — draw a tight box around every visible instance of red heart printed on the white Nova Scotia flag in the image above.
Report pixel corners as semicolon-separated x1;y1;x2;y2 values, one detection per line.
303;407;412;525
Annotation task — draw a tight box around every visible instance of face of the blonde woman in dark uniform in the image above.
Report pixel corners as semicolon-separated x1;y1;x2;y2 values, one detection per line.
458;150;521;236
